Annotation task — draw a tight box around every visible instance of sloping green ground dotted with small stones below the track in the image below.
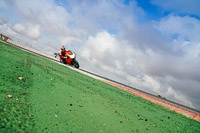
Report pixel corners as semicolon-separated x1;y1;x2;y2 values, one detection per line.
0;42;200;133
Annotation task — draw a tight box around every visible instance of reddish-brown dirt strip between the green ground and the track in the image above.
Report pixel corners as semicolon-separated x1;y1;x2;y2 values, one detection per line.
101;80;200;122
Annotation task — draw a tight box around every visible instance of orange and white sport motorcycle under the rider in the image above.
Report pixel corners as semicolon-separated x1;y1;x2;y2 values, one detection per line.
54;50;79;68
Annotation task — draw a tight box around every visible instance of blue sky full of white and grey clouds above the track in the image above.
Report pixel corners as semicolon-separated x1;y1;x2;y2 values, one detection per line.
0;0;200;110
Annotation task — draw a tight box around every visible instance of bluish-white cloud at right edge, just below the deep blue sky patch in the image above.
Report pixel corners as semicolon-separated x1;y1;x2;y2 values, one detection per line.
155;14;200;41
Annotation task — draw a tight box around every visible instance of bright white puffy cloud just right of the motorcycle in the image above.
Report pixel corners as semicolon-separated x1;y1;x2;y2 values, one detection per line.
81;31;160;92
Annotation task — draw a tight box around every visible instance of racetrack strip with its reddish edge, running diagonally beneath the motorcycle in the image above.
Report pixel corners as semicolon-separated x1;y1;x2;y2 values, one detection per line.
1;41;200;122
